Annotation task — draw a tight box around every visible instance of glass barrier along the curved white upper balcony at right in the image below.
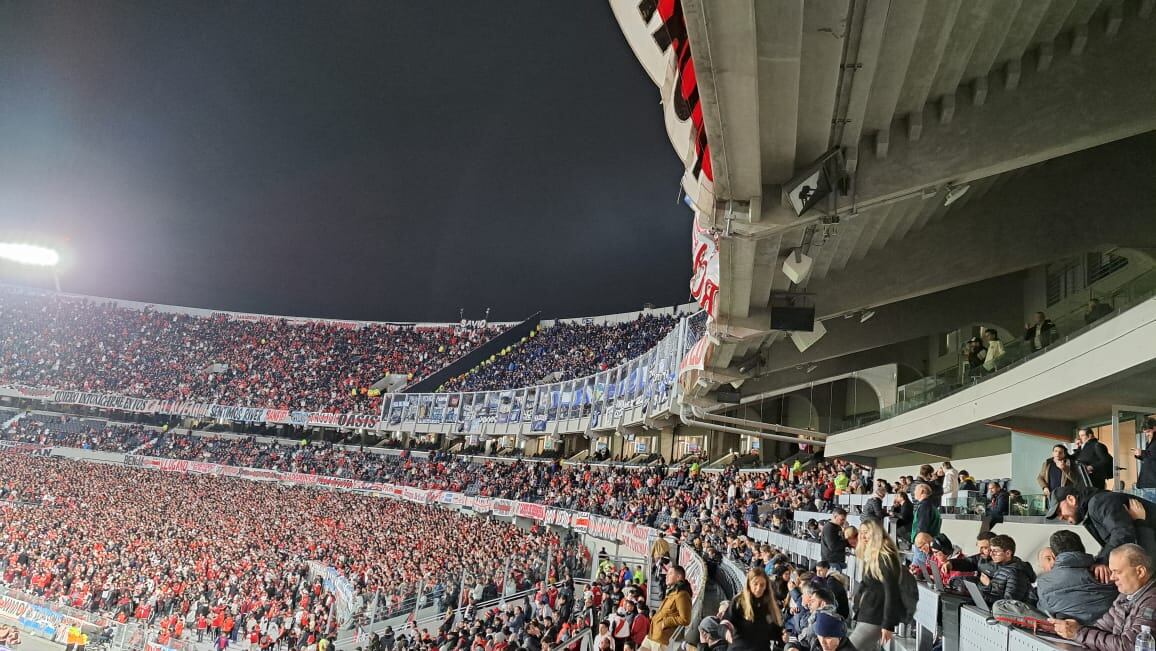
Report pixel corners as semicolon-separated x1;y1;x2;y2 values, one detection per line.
869;269;1156;431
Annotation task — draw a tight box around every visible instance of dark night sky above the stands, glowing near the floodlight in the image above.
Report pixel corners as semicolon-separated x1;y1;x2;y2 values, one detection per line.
0;0;691;320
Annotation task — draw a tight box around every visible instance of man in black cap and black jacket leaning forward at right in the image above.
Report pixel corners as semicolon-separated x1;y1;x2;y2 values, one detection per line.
1046;486;1156;583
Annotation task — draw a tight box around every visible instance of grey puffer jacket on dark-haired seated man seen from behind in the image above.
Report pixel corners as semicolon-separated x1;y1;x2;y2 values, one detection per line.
1036;552;1119;626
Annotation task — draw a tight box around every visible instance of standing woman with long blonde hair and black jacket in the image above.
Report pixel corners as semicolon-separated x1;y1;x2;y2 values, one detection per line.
851;518;904;651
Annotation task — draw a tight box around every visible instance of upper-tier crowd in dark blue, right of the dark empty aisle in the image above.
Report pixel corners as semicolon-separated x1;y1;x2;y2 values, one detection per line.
440;315;679;391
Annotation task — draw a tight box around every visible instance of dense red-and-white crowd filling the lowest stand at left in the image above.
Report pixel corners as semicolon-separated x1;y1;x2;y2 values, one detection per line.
0;454;588;649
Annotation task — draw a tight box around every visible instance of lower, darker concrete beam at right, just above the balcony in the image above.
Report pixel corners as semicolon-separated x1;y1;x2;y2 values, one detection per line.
808;134;1156;318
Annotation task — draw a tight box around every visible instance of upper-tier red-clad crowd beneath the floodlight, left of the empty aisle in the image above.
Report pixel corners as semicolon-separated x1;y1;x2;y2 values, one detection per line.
0;290;498;413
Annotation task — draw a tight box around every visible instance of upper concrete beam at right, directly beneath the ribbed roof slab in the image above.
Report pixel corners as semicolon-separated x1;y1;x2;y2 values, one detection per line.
840;12;1156;209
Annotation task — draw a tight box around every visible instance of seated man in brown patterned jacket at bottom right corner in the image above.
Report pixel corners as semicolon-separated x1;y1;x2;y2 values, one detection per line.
1051;542;1156;651
